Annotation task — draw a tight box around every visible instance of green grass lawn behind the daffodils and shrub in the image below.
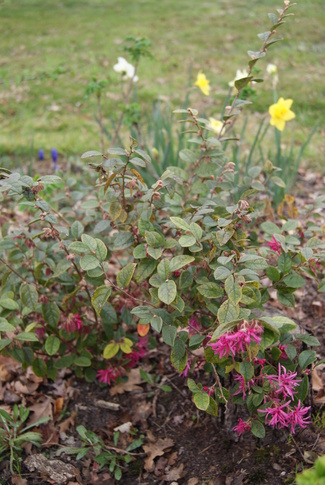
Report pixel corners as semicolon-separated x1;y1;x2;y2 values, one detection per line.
0;0;325;166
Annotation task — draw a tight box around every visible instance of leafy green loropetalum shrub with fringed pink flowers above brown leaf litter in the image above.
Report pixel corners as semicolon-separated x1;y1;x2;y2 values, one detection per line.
0;1;325;438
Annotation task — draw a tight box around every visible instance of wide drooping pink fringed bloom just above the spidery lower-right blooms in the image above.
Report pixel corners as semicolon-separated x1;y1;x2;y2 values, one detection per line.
208;320;264;359
